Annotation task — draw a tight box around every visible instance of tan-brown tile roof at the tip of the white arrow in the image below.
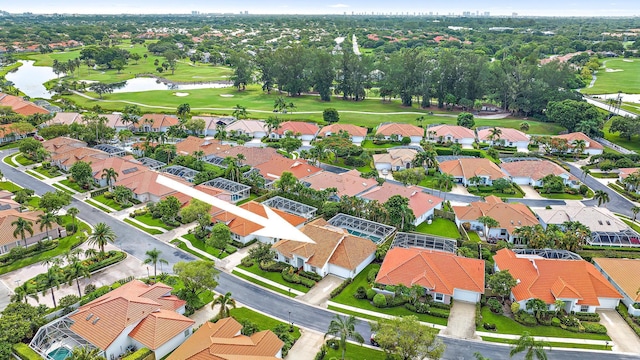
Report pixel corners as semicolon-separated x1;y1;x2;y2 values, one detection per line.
273;220;377;270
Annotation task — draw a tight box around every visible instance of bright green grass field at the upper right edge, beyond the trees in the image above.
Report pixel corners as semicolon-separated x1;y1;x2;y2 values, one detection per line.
582;58;640;94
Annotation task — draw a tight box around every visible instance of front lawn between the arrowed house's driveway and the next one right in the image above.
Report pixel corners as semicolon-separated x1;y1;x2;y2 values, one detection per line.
331;264;447;325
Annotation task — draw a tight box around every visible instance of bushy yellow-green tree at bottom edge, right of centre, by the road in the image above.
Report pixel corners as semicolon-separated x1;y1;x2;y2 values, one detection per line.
372;315;445;360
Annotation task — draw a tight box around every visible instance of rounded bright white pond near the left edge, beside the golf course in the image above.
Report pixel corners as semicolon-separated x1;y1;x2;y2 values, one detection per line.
5;60;58;99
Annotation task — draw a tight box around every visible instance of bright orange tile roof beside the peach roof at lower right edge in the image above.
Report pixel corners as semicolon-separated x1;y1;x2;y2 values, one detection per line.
493;249;622;306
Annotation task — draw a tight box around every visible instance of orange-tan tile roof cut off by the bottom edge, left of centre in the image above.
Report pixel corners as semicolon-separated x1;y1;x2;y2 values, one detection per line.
167;317;284;360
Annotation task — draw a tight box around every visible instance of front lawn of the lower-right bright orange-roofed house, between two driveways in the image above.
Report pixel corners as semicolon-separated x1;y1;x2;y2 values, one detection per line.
477;306;611;340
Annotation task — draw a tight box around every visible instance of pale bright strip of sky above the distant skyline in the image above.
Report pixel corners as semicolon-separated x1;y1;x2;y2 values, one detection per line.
5;0;640;16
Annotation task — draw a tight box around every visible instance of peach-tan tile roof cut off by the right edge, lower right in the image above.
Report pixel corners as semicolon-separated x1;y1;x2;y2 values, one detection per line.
593;258;640;302
